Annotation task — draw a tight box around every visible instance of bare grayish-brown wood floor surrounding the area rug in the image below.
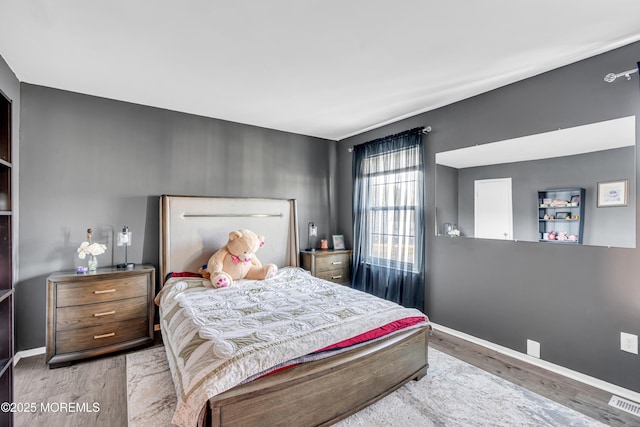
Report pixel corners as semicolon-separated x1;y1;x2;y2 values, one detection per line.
14;331;640;427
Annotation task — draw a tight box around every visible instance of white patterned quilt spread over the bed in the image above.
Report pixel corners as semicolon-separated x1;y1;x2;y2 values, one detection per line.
159;268;427;427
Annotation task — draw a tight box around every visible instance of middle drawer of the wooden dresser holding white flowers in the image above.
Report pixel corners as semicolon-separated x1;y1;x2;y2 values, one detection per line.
56;297;149;331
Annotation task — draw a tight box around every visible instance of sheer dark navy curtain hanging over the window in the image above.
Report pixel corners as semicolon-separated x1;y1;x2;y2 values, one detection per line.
352;128;425;311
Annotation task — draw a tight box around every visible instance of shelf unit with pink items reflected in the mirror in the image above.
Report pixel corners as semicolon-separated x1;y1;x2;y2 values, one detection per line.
538;188;585;245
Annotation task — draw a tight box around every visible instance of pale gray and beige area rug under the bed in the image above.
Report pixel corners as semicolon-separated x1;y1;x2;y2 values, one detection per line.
127;347;604;427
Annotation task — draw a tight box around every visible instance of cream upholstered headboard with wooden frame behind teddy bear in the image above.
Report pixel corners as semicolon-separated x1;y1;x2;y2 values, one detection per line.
160;195;299;283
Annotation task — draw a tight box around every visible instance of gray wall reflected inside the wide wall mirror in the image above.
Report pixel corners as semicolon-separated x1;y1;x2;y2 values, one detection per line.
456;147;636;248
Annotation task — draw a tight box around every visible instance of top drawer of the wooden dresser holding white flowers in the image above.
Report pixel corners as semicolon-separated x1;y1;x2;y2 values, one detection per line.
56;275;149;307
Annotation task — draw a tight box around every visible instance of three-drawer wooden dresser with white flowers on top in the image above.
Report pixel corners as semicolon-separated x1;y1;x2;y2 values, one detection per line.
46;265;155;368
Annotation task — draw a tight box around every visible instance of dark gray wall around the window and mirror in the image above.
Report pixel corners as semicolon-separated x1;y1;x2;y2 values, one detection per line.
337;43;640;391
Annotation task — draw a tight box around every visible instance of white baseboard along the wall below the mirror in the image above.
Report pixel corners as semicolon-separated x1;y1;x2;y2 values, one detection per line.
431;322;640;402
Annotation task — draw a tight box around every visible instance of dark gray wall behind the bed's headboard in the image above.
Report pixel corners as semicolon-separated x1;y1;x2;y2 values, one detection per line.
16;84;336;350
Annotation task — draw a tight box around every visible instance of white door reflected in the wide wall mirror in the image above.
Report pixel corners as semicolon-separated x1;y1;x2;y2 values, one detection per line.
474;178;513;240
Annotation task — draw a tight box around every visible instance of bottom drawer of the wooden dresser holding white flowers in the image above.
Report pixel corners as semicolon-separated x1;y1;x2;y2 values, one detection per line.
55;317;149;353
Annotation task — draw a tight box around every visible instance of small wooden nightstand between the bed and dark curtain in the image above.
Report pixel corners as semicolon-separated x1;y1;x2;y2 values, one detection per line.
300;249;352;285
